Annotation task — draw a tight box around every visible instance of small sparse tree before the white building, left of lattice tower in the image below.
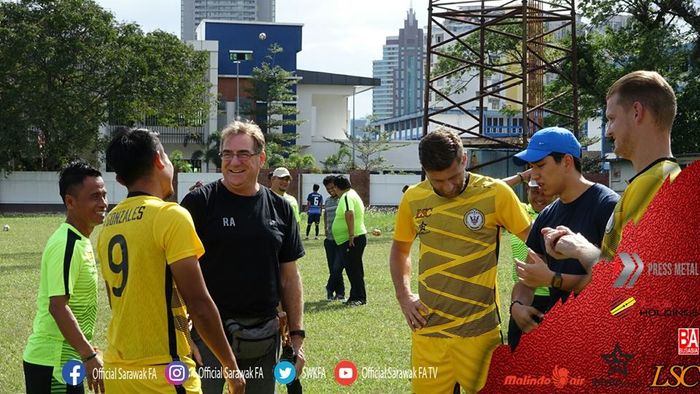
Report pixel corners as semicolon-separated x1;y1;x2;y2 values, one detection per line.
323;122;408;172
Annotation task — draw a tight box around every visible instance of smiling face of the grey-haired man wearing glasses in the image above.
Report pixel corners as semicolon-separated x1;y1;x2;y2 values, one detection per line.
221;134;265;195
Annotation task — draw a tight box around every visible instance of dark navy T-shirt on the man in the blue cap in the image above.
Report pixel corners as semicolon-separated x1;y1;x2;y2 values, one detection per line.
527;183;620;306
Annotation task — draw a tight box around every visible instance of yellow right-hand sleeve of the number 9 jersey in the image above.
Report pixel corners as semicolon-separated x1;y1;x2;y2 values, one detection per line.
153;204;204;264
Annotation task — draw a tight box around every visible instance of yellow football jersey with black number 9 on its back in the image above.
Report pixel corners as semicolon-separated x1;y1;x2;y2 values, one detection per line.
97;195;204;365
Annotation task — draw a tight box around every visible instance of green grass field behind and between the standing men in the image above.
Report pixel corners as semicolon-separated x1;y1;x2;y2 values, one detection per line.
0;210;512;393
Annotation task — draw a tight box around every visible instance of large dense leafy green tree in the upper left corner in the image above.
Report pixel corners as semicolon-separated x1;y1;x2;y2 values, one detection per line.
0;0;208;170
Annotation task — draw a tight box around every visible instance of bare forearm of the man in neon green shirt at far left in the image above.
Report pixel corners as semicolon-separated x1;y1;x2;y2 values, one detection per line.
49;295;104;393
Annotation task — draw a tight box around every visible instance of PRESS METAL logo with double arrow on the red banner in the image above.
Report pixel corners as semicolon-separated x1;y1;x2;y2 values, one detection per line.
613;253;700;289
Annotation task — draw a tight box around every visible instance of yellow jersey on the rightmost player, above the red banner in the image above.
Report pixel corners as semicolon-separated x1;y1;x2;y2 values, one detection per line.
601;159;681;260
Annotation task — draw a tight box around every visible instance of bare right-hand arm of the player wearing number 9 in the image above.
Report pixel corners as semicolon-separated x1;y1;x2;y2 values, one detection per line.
170;256;245;393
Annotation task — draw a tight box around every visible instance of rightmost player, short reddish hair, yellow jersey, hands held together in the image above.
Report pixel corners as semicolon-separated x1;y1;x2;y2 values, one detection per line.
543;71;681;265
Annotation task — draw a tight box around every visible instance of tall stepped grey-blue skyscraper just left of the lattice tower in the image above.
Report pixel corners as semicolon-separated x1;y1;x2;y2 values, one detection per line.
372;9;425;119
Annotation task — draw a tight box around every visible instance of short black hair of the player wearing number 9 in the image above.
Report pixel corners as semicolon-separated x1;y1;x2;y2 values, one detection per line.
106;127;163;187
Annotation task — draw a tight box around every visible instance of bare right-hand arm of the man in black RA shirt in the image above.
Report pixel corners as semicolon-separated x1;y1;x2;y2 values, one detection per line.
280;261;306;376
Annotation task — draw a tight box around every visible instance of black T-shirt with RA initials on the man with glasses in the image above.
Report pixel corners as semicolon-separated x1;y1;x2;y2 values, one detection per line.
181;180;304;318
